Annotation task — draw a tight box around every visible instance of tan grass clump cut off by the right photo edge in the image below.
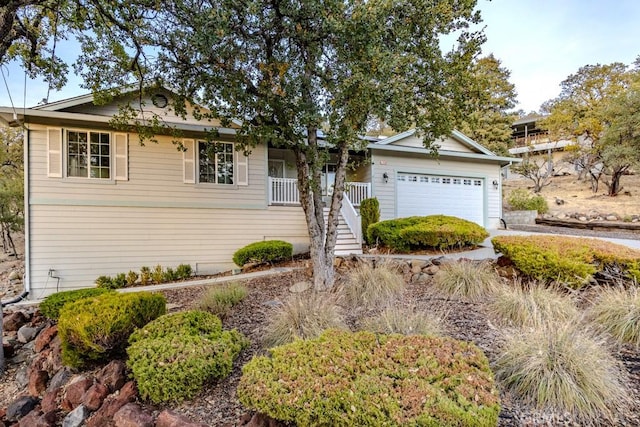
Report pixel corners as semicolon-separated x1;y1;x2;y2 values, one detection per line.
587;287;640;347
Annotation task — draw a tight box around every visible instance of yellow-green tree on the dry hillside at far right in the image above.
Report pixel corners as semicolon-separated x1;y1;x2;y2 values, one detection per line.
540;62;632;195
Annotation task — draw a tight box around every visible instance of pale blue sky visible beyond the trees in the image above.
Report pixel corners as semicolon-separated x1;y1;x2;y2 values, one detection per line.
0;0;640;112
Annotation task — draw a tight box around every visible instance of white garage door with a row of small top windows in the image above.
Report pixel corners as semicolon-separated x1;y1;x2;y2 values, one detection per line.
398;173;484;226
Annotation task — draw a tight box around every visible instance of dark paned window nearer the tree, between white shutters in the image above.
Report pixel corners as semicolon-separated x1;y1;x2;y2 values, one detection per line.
198;141;234;184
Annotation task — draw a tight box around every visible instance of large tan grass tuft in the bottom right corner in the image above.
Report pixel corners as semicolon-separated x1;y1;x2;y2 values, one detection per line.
494;322;628;425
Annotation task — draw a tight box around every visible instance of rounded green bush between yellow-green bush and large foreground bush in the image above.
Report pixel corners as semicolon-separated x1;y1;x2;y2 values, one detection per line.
127;311;248;403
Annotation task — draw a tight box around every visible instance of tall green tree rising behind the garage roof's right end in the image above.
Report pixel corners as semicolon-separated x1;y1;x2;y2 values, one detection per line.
459;55;517;155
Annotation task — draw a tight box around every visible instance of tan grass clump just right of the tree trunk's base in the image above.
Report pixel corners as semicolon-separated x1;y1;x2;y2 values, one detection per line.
342;261;406;308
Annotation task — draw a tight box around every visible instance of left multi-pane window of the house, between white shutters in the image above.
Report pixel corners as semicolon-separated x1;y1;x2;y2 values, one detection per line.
67;130;111;179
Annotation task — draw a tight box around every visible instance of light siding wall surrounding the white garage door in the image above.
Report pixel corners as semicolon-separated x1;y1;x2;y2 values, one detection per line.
371;150;502;228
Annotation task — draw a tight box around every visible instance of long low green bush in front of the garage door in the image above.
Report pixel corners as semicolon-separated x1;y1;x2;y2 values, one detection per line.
368;215;489;252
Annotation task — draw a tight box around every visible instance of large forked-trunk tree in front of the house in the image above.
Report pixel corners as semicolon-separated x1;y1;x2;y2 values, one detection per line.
72;0;484;289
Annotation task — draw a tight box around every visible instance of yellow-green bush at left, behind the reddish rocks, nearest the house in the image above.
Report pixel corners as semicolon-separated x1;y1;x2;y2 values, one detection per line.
58;292;166;367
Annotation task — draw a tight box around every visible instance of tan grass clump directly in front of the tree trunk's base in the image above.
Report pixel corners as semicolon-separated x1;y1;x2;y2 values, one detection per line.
264;292;347;347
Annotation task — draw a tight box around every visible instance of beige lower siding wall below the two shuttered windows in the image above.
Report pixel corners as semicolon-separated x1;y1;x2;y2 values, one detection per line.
31;206;308;298
